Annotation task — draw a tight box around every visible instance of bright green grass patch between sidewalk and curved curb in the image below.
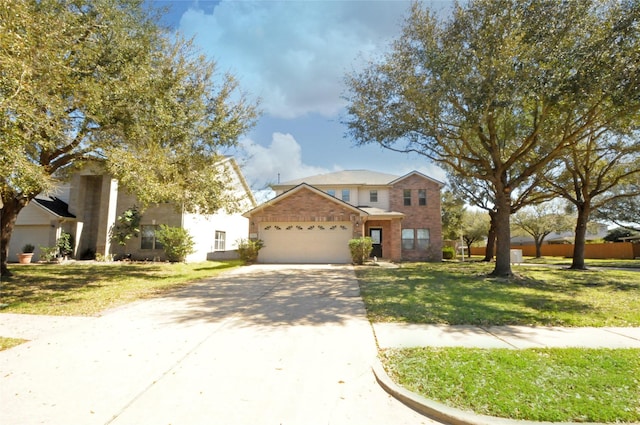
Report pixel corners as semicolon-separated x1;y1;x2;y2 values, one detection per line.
381;348;640;422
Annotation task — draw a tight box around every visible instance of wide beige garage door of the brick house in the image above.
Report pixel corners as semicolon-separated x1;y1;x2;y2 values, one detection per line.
258;221;353;264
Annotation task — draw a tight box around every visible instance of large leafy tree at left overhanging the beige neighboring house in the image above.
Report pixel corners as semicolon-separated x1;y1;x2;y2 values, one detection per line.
0;0;257;275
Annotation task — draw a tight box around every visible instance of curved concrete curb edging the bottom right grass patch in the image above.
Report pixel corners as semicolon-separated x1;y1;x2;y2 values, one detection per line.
371;362;616;425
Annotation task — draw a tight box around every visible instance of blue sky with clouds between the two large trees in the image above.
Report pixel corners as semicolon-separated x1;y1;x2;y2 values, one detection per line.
148;0;451;189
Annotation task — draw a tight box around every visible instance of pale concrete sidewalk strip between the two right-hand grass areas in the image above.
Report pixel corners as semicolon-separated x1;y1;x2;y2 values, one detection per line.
373;323;640;349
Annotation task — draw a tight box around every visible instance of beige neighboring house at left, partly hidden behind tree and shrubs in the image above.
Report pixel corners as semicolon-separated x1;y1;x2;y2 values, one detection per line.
9;158;256;261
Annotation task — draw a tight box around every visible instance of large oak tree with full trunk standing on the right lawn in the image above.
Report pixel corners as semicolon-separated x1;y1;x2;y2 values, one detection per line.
345;0;640;276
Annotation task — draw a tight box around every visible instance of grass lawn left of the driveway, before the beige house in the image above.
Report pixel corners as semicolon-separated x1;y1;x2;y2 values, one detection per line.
0;262;240;316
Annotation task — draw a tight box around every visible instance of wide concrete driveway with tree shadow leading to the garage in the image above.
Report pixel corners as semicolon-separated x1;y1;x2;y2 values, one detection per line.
0;265;435;425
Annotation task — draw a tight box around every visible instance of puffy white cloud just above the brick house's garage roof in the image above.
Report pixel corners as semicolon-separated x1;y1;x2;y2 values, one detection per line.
241;133;329;189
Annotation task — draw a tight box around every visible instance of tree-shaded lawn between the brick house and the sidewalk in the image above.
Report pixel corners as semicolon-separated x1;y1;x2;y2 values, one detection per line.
356;262;640;327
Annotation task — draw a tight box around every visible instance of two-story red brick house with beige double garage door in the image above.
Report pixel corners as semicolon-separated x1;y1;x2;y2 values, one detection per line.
244;170;443;263
